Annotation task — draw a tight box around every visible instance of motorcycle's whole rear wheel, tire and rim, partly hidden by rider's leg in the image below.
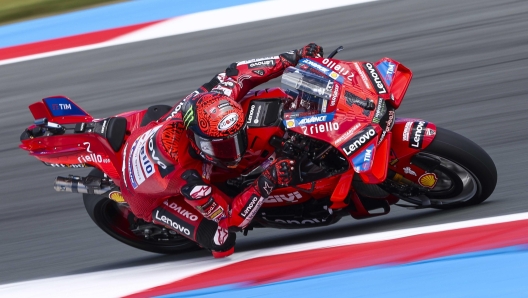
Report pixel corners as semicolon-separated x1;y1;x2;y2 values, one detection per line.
83;170;198;254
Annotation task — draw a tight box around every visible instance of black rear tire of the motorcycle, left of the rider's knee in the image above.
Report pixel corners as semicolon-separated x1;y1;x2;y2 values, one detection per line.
83;169;198;254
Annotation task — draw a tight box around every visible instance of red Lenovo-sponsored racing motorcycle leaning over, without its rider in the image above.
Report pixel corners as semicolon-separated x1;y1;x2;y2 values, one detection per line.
20;47;497;253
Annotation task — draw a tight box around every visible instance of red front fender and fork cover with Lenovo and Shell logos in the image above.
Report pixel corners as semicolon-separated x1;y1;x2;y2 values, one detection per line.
389;118;437;188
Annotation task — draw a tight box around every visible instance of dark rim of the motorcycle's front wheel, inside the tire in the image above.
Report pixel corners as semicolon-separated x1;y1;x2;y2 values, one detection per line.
422;152;480;205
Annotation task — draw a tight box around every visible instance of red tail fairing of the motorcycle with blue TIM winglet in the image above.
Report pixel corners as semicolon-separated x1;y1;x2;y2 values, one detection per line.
19;96;150;185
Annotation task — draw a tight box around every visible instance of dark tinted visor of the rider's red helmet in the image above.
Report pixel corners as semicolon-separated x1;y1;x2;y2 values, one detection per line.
194;127;247;162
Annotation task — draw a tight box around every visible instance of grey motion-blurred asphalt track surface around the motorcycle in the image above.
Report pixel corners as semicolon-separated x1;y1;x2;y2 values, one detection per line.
0;0;528;284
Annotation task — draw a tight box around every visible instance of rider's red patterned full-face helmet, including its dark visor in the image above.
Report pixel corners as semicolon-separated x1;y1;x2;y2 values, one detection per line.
182;92;248;168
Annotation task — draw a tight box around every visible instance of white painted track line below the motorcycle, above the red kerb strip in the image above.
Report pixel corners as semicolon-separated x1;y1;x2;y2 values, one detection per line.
0;212;528;297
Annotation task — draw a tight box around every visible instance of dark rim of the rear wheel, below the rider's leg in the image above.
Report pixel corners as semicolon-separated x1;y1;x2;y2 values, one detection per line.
98;198;190;248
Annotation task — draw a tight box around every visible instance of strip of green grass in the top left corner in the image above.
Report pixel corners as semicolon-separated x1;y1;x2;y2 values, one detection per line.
0;0;124;25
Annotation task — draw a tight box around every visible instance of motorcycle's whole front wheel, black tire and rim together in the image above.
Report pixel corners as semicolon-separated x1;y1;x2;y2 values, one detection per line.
402;127;497;209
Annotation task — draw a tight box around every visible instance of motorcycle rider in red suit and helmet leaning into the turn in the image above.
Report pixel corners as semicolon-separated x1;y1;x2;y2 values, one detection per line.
121;43;323;257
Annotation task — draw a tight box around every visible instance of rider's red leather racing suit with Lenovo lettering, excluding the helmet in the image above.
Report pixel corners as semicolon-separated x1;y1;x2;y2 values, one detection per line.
121;51;300;249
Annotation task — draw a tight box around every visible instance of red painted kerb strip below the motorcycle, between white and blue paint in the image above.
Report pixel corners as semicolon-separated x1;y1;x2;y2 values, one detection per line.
126;220;528;298
